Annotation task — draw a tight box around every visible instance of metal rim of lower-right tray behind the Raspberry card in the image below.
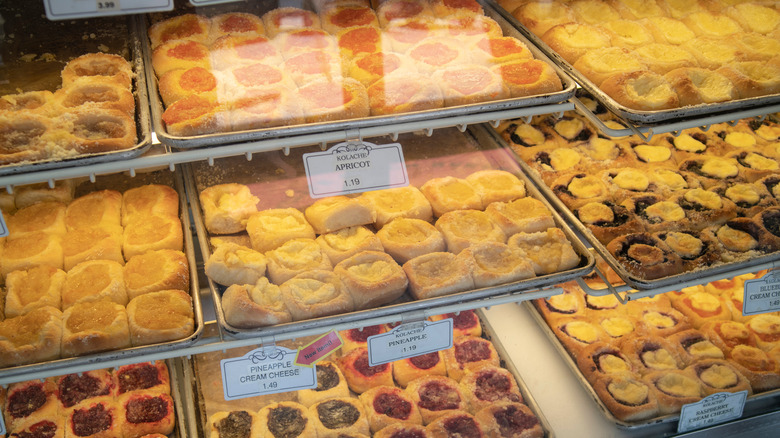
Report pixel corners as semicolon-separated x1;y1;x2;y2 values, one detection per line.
523;301;780;434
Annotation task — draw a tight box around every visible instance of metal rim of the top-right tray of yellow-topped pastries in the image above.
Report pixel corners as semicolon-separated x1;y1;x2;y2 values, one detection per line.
486;0;780;126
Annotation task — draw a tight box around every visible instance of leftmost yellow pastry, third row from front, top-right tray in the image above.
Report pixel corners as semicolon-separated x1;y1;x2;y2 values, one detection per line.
541;23;611;64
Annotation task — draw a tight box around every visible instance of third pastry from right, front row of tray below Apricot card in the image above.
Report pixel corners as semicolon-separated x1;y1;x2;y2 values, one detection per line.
403;252;474;300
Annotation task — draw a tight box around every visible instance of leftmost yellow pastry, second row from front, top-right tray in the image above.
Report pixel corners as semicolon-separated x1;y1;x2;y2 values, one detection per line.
574;47;644;86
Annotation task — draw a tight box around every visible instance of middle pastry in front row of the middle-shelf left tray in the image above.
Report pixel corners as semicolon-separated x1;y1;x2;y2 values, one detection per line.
62;299;130;357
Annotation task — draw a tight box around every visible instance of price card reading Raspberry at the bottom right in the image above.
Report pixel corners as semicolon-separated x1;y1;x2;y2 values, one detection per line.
677;391;747;433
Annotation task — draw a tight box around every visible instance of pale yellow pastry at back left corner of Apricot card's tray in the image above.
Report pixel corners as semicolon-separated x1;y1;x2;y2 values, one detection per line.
200;183;260;234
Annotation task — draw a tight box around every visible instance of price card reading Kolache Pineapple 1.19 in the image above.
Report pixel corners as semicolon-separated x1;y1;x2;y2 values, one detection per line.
367;318;453;367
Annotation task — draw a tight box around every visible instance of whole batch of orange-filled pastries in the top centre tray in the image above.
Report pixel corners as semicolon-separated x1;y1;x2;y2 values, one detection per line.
149;0;562;136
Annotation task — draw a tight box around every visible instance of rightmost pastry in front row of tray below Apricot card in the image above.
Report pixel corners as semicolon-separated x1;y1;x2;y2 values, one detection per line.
507;228;580;275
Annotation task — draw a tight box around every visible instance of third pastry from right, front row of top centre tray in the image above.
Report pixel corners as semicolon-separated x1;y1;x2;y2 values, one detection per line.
368;72;444;116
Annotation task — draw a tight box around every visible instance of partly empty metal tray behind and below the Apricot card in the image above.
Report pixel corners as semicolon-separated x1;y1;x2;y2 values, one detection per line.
185;125;595;338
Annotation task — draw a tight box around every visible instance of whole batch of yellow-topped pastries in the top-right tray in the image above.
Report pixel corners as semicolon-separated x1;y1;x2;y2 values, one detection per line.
499;0;780;111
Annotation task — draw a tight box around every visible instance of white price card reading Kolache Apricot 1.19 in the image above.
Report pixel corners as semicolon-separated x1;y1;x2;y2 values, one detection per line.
303;141;409;198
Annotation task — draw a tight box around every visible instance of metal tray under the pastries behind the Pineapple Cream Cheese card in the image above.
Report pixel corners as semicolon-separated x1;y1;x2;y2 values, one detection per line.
184;310;555;438
